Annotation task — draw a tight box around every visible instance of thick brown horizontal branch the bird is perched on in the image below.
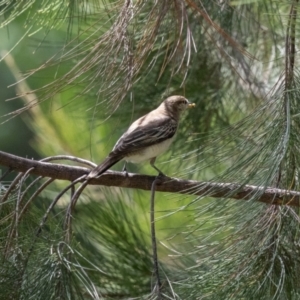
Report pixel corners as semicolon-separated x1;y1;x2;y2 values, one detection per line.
0;151;300;206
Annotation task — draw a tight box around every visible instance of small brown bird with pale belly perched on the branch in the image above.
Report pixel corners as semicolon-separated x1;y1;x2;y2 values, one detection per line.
86;96;195;179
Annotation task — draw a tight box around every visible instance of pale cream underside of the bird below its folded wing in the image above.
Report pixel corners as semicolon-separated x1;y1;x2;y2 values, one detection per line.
125;138;173;163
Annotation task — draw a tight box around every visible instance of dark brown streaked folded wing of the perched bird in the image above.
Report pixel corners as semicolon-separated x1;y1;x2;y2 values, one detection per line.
111;116;178;157
